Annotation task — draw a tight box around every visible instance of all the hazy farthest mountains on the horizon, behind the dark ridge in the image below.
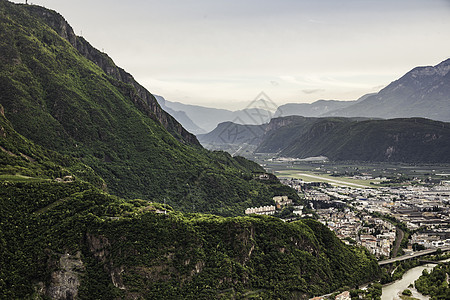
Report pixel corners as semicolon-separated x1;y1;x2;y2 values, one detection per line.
167;59;450;134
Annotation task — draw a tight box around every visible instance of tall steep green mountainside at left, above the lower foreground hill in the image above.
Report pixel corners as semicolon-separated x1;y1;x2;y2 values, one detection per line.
0;0;292;215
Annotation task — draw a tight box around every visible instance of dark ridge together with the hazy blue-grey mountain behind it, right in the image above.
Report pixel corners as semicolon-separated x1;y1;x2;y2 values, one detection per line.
197;59;450;162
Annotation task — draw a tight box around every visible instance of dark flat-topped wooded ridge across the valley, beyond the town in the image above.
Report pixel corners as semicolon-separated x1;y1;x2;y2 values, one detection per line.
256;117;450;163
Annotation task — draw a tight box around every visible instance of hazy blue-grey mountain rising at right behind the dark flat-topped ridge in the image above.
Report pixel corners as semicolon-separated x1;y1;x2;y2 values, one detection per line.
268;59;450;122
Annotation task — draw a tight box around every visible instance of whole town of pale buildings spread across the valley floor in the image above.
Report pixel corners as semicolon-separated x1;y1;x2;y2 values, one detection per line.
245;159;450;260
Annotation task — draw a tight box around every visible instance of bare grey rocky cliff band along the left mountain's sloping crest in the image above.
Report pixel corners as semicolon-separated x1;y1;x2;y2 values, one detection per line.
27;5;200;146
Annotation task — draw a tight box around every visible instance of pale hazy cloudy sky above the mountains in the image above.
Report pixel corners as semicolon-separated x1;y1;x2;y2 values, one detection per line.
15;0;450;109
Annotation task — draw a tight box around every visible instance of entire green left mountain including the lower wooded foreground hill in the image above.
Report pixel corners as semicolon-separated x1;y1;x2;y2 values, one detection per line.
0;0;379;299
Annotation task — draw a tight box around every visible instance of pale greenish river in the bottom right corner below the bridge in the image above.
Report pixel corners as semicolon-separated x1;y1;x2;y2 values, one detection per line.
381;259;448;300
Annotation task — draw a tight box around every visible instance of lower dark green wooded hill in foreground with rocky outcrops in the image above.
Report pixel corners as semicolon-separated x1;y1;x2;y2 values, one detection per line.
0;181;378;299
